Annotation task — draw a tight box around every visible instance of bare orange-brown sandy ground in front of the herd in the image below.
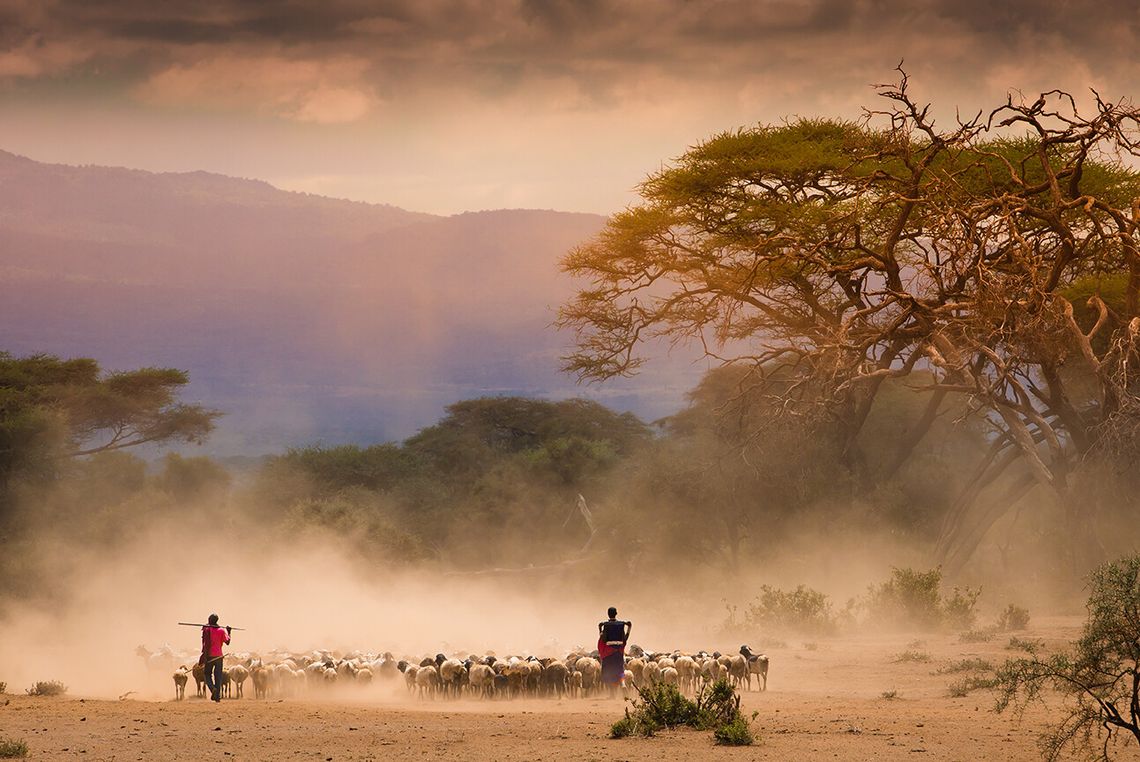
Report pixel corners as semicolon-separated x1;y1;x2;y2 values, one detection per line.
0;617;1080;761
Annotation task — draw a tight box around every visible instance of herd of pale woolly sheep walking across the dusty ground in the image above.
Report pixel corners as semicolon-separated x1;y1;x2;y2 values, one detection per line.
137;646;768;699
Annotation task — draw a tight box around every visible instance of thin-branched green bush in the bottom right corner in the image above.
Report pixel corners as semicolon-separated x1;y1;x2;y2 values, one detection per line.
996;556;1140;760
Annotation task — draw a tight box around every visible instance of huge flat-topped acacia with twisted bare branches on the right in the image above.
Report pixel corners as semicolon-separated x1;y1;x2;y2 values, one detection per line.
559;72;1140;572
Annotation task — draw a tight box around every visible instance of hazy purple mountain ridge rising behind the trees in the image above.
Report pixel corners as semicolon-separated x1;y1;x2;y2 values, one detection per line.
0;152;697;453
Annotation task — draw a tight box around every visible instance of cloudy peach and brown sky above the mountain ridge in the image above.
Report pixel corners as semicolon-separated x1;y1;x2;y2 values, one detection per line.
0;0;1140;214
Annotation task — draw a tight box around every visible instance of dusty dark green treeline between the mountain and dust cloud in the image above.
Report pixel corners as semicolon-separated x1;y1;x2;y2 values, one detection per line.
0;355;1016;593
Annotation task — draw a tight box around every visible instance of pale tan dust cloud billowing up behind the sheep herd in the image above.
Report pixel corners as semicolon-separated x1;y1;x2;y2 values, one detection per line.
0;481;1076;699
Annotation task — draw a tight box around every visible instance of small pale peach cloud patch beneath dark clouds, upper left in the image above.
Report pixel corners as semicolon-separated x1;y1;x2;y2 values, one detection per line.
133;55;378;124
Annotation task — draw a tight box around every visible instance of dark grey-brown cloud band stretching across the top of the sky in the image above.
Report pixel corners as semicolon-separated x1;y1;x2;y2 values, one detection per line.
0;0;1140;116
